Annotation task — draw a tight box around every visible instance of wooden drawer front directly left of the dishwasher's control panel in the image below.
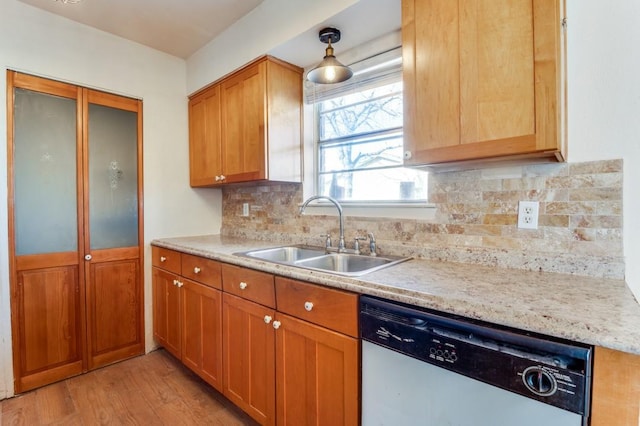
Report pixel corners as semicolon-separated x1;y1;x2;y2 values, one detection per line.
276;277;358;337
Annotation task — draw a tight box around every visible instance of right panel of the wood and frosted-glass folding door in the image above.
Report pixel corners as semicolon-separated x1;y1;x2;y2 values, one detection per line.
83;89;144;369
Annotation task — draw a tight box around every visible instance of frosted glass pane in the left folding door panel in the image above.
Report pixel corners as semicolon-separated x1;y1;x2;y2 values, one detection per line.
14;88;78;256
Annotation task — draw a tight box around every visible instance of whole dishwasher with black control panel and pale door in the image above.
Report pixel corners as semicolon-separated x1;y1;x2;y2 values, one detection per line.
360;296;593;426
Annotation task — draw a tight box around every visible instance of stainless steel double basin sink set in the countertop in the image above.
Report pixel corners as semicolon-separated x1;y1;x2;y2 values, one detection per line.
235;245;410;276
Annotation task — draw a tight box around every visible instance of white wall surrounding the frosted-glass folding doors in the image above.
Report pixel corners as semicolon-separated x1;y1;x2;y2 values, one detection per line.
0;0;221;399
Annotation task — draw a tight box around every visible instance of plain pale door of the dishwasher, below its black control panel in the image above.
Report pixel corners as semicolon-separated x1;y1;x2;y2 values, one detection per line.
362;340;583;426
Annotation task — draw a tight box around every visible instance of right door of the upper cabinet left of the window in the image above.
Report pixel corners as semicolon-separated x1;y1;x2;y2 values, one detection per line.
221;62;267;183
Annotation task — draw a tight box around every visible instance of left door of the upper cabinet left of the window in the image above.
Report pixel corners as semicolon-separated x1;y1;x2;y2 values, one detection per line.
189;85;222;187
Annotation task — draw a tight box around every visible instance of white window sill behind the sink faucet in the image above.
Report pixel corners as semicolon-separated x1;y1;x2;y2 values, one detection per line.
298;200;436;220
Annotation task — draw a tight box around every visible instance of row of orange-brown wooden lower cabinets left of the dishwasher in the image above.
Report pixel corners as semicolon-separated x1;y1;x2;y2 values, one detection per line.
153;247;360;426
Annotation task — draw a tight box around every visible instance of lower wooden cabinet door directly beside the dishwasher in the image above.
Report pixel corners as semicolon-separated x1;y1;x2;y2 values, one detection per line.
276;314;360;425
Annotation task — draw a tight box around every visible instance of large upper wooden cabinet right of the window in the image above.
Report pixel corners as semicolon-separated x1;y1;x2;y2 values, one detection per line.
402;0;565;166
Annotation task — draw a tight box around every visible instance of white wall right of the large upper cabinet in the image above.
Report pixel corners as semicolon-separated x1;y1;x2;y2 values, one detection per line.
567;0;640;300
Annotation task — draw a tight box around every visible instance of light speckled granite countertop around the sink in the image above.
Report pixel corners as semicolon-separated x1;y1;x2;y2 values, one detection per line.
151;235;640;354
